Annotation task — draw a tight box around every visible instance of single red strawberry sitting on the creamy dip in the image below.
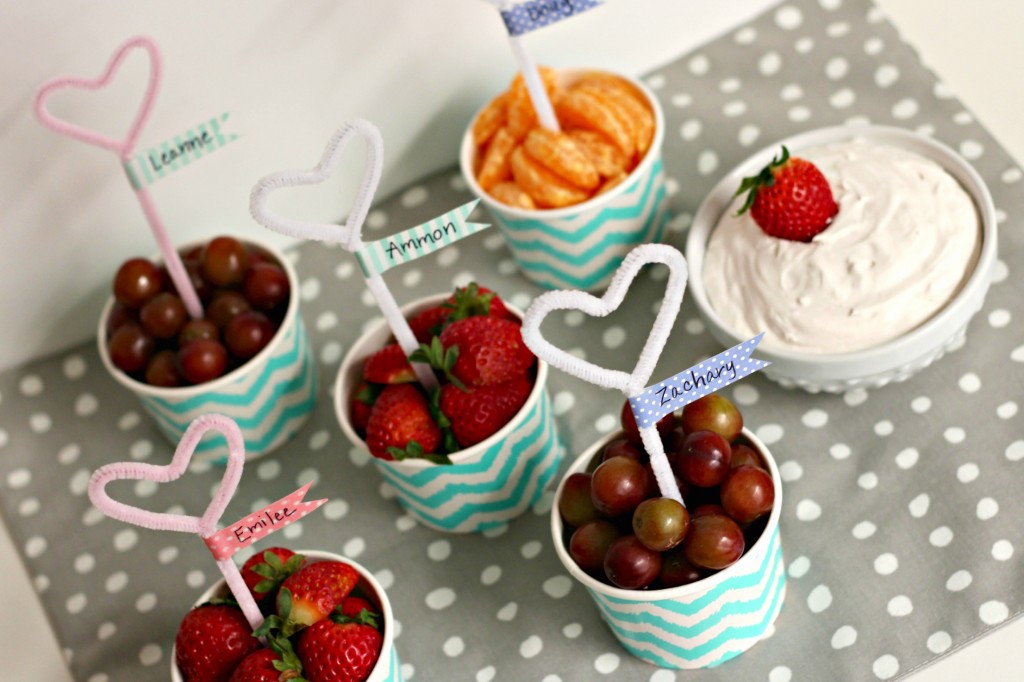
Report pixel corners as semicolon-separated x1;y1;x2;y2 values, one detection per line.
735;146;839;242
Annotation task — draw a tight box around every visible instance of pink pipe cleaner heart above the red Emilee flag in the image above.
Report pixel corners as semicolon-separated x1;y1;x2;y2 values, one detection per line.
88;415;246;538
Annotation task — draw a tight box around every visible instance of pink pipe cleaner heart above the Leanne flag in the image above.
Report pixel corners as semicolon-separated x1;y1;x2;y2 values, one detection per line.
35;36;161;159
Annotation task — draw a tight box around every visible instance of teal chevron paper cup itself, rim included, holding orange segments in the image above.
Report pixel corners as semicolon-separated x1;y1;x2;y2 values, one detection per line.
459;70;669;291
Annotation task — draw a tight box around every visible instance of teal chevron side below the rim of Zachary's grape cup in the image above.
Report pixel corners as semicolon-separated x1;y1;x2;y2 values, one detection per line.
588;525;785;669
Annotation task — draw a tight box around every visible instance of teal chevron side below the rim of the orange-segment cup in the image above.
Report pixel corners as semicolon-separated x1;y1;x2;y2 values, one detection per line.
492;157;669;291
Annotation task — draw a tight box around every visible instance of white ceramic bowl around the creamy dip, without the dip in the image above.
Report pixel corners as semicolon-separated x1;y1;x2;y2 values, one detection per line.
686;126;997;393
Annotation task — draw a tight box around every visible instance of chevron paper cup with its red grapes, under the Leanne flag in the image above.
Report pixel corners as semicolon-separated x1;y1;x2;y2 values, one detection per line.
97;236;316;462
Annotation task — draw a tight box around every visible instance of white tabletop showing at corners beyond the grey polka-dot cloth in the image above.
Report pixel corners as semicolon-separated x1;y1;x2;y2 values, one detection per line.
0;0;1024;682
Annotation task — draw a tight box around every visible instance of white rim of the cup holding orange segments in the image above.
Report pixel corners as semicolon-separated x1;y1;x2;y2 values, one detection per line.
459;67;665;220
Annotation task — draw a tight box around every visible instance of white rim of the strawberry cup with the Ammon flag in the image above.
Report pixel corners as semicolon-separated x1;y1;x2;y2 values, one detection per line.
332;294;548;469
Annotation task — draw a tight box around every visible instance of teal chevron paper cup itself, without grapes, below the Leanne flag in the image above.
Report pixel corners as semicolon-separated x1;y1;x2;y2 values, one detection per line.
97;235;316;464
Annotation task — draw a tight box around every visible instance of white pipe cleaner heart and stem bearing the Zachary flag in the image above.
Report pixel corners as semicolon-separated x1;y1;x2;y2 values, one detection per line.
522;244;687;504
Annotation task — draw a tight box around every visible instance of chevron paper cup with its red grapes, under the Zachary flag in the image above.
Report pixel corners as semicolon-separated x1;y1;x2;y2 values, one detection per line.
551;393;785;669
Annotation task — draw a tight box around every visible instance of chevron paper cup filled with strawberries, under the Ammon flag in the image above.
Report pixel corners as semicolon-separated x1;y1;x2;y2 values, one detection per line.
334;283;561;532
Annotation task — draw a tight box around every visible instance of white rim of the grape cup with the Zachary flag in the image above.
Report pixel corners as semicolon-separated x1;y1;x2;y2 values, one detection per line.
550;427;782;601
